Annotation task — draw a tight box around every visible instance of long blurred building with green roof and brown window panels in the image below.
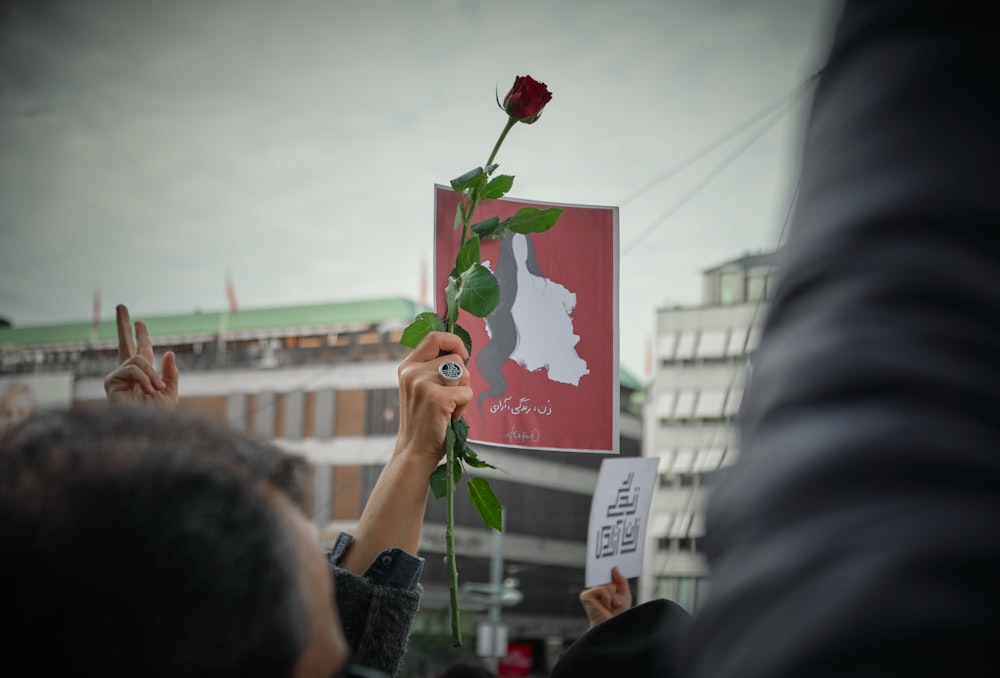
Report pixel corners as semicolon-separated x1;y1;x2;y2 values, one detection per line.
0;299;642;675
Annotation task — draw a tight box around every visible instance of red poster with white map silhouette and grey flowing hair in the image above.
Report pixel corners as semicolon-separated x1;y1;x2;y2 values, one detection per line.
434;186;619;454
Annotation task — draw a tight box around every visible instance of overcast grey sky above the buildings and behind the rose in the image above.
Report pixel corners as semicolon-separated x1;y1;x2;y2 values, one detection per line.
0;0;830;376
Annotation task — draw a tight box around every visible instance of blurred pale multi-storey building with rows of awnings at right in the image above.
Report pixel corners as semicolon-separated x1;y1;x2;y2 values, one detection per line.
639;254;775;611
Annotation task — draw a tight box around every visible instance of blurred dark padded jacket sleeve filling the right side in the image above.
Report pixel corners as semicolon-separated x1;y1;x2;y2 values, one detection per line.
685;0;1000;678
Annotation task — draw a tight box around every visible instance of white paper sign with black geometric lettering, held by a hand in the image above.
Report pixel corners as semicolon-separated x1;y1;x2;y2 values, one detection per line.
584;457;659;588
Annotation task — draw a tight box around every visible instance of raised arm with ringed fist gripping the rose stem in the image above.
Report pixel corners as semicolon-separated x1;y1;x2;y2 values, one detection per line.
330;332;472;675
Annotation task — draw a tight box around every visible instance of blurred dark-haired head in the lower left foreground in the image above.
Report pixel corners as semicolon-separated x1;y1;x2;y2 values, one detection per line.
0;407;347;678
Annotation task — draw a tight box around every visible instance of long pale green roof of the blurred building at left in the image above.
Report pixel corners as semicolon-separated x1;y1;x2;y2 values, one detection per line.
0;298;417;348
